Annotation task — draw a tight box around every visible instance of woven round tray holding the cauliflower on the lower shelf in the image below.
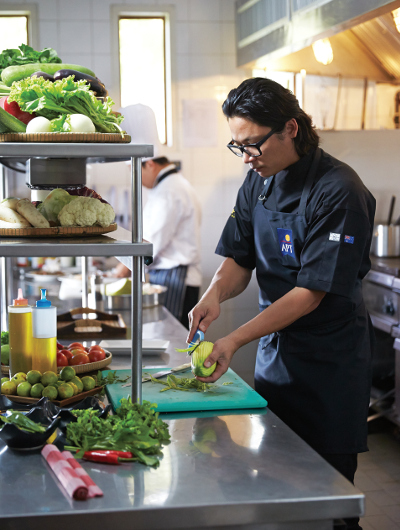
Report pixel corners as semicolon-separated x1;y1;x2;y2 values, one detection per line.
0;223;118;237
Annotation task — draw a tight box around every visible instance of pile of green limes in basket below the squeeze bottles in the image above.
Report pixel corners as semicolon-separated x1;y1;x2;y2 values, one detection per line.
1;366;96;401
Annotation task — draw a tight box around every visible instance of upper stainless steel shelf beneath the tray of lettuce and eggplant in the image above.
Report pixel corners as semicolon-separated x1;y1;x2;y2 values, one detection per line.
0;142;153;159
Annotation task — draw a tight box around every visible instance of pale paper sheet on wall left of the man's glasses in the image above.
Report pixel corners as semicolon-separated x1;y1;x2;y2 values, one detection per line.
182;98;220;147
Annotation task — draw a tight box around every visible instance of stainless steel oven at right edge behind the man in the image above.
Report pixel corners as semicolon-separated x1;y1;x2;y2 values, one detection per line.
363;257;400;425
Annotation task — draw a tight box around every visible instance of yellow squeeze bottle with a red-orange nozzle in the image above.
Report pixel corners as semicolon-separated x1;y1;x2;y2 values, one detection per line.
8;289;32;377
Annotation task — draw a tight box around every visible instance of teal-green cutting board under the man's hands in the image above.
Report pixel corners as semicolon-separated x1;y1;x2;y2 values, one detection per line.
103;368;267;412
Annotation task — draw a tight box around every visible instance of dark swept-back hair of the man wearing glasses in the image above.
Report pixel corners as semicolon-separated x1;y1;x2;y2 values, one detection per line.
222;77;319;156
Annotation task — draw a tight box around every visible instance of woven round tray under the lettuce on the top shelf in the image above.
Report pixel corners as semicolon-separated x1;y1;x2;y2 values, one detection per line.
0;133;131;144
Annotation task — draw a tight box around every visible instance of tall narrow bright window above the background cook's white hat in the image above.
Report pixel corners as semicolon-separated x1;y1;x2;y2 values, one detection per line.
118;14;170;144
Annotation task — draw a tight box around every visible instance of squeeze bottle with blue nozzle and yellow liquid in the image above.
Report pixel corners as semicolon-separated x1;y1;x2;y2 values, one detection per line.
32;289;57;374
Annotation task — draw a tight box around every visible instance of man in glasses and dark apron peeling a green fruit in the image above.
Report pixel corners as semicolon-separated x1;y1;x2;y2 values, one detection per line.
188;78;375;529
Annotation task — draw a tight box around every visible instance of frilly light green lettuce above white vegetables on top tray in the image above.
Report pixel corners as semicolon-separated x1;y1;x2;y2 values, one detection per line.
8;76;123;133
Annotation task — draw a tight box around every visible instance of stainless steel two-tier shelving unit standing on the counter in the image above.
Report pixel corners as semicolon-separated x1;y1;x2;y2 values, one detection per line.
0;142;153;402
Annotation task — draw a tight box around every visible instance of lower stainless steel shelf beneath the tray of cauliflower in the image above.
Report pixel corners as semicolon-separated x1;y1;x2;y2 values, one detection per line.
0;236;153;258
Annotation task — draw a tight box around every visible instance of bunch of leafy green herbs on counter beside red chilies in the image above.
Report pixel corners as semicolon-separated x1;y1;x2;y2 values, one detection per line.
67;397;170;467
